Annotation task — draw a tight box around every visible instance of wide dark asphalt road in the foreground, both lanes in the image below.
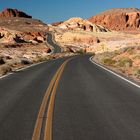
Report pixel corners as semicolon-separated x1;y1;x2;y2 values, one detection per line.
0;56;140;140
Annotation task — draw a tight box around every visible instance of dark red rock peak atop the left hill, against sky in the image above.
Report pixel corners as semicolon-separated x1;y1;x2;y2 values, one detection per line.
0;8;32;18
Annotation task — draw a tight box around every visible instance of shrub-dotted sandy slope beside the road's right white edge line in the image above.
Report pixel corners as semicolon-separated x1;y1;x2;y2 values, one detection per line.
95;46;140;81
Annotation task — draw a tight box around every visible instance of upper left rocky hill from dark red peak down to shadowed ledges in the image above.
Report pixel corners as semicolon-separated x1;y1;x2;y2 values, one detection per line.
0;8;48;43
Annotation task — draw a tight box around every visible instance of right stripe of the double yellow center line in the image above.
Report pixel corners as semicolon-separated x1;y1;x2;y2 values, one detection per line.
44;60;69;140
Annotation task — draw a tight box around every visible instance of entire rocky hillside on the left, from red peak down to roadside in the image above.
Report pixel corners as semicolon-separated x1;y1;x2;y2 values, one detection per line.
0;9;51;76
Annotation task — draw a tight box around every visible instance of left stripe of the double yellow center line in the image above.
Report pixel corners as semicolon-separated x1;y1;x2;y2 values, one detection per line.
32;60;70;140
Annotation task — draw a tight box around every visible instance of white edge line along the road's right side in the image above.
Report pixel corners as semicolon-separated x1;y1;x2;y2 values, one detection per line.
89;56;140;88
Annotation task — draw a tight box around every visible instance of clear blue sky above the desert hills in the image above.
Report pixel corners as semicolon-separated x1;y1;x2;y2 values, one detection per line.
0;0;140;23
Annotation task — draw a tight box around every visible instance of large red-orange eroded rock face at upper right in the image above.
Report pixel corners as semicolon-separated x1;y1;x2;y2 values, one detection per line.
89;8;140;30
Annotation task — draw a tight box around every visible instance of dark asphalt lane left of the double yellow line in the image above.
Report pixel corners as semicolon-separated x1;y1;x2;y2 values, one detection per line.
0;58;66;140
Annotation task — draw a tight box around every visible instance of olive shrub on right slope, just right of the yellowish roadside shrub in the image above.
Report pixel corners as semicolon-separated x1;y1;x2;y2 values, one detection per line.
118;58;133;67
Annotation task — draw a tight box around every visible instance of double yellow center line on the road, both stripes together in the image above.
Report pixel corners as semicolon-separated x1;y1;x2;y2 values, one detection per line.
32;59;70;140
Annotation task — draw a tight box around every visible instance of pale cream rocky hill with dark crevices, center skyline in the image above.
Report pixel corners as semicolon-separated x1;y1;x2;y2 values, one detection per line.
55;17;109;32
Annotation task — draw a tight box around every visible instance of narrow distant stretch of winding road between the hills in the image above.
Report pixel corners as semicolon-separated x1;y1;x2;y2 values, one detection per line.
46;32;61;53
